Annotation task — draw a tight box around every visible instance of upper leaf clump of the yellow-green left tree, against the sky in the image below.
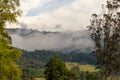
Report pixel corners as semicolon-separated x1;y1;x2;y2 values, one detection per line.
0;0;21;24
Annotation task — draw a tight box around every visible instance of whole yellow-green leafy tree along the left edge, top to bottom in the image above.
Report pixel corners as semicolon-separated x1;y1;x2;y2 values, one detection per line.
0;0;21;80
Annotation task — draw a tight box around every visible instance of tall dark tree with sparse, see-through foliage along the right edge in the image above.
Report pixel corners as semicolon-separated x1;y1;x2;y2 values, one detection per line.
88;0;120;80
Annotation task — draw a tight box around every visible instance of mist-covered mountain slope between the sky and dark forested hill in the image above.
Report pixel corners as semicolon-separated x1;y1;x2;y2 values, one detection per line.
7;28;93;51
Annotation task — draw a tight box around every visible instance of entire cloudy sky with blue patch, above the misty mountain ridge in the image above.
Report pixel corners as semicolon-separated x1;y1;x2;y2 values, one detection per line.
9;0;106;31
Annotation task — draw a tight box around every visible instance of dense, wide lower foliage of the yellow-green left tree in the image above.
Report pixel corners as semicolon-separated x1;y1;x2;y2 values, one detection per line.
0;46;21;80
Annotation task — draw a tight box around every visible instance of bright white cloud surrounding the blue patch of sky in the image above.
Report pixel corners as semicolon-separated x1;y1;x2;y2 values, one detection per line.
8;0;105;30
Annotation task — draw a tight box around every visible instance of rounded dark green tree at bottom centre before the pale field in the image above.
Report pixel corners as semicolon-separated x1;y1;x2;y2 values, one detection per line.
44;56;74;80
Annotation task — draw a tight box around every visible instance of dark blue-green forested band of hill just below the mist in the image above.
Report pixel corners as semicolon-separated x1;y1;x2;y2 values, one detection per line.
21;50;97;65
